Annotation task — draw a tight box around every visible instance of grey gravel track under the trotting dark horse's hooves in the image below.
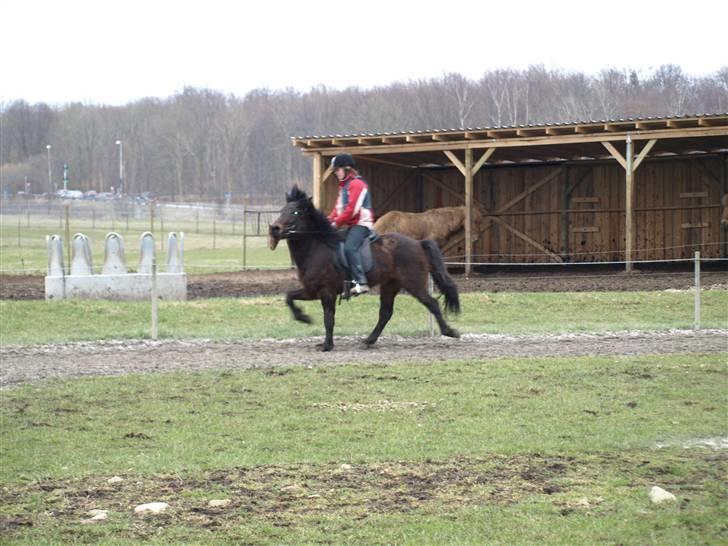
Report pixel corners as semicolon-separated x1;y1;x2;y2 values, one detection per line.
0;330;728;387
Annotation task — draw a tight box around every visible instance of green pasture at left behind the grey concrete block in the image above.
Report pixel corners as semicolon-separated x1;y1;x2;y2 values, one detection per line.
0;214;291;274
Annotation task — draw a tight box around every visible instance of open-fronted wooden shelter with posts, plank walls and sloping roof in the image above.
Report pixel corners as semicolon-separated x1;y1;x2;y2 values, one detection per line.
292;113;728;273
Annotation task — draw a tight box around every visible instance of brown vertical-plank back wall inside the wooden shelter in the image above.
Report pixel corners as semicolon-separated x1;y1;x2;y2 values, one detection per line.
336;157;721;263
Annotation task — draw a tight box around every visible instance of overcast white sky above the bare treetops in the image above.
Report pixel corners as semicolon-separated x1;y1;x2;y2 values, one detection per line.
0;0;728;104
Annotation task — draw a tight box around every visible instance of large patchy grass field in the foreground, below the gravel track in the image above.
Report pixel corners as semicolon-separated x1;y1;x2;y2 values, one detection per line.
0;354;728;544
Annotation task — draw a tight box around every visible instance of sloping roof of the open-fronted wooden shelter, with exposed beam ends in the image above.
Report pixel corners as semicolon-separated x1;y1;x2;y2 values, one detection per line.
291;109;728;163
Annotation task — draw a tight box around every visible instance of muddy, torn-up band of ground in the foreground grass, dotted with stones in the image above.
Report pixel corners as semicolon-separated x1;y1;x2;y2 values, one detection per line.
0;451;728;540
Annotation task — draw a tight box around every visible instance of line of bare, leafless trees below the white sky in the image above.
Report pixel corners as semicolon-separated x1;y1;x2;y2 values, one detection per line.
0;65;728;201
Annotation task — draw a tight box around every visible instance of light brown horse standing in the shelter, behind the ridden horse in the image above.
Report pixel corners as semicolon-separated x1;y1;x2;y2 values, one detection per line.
374;207;481;248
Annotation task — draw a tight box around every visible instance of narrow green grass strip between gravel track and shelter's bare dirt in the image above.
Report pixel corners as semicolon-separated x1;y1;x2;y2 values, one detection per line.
0;290;728;344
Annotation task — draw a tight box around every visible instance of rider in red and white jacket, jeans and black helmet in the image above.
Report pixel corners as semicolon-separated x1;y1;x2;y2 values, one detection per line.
329;153;374;296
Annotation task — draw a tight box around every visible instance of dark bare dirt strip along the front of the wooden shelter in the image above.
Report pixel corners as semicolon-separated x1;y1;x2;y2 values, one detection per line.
0;266;728;300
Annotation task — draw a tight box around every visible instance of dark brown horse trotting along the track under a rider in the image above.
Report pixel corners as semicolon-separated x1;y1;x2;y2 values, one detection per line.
269;186;460;351
